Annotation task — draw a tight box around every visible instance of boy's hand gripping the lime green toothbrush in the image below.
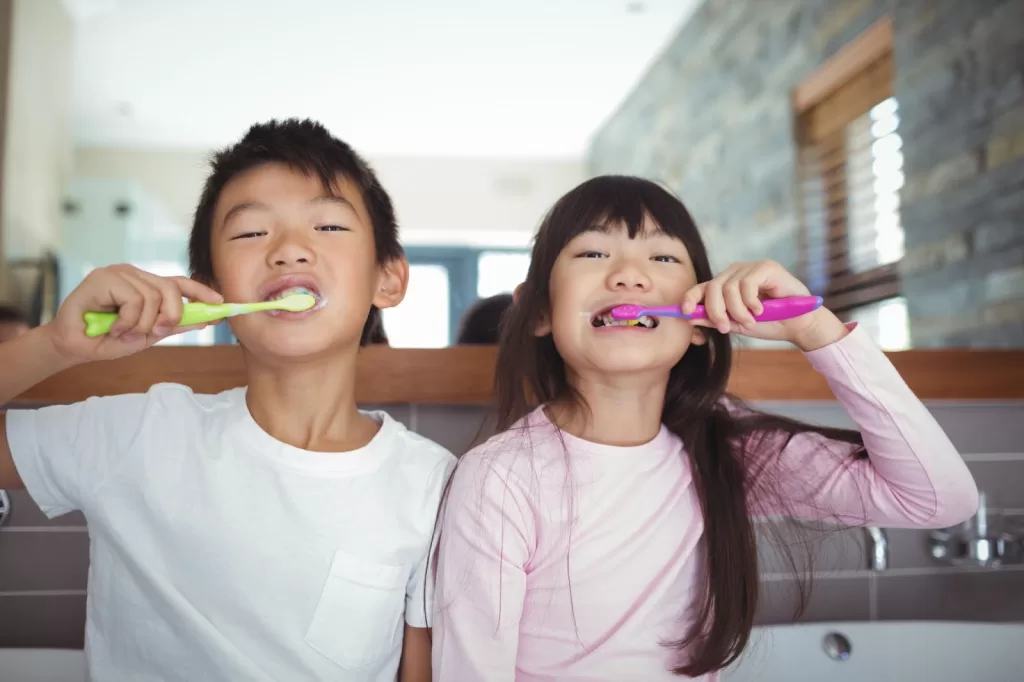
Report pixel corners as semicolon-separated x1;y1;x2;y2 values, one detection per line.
45;265;223;364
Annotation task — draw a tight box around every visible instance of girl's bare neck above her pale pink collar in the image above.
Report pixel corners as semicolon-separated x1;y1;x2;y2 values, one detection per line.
552;366;669;446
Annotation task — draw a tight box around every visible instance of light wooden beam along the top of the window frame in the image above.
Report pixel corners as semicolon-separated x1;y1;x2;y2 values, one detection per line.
793;16;893;116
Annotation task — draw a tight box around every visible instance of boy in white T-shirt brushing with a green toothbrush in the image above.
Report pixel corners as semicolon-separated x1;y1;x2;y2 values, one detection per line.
0;120;454;682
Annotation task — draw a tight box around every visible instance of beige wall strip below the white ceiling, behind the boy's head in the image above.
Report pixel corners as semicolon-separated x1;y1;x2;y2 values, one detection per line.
75;147;584;246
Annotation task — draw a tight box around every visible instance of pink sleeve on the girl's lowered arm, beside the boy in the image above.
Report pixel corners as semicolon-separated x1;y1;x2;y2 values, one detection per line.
432;445;536;682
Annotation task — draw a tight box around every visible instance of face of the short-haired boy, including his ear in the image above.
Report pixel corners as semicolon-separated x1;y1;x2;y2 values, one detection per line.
211;164;409;360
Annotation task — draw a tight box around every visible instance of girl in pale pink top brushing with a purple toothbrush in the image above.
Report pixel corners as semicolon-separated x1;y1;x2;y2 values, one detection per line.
433;177;977;682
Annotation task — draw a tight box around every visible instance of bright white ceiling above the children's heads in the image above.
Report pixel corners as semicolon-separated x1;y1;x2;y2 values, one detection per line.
65;0;701;157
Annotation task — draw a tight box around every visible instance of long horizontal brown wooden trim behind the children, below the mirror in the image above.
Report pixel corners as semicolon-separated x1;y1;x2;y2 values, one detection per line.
8;346;1024;404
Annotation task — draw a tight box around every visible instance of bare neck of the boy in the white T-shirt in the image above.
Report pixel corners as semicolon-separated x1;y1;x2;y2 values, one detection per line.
246;353;380;453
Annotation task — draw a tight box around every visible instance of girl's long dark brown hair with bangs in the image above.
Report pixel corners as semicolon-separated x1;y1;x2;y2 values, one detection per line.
483;176;864;677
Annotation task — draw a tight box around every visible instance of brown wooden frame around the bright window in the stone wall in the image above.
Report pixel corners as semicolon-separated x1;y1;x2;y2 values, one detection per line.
793;16;901;313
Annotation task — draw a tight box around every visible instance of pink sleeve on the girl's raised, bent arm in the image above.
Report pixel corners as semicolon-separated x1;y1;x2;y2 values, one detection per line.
759;327;978;527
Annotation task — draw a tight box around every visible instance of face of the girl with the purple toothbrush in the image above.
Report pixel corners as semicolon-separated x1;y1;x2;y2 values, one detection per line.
537;217;705;375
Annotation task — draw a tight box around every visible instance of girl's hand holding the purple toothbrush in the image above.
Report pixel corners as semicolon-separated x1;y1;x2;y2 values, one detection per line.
682;260;848;351
